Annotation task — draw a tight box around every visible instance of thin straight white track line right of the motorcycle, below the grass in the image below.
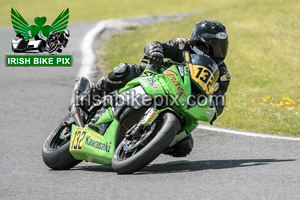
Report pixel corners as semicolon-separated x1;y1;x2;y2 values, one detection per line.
197;124;300;141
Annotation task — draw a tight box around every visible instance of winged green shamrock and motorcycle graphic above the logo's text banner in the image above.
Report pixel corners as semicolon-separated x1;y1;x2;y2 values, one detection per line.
11;8;70;53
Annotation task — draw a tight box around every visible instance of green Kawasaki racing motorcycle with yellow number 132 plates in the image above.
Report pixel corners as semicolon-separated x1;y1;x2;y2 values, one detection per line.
42;52;219;174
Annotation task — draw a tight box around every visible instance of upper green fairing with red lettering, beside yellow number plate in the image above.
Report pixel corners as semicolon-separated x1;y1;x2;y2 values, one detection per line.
118;65;216;133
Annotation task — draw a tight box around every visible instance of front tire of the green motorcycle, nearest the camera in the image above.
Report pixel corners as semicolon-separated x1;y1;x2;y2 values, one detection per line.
112;112;180;174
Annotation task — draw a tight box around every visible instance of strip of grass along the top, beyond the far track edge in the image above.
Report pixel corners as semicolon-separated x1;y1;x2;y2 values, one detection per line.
0;0;230;26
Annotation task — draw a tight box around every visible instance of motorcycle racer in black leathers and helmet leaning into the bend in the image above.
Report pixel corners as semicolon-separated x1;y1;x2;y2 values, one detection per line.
78;20;230;157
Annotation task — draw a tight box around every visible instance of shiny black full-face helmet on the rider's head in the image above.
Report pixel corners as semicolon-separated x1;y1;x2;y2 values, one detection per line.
191;20;228;65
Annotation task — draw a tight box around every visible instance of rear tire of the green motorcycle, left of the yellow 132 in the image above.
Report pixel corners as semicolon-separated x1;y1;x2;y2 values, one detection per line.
42;114;81;170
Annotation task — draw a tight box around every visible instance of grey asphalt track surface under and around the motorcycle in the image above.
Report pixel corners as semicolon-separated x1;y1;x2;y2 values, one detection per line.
0;16;300;200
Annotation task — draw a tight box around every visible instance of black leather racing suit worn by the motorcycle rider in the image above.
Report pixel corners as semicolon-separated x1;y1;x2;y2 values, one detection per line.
94;38;230;116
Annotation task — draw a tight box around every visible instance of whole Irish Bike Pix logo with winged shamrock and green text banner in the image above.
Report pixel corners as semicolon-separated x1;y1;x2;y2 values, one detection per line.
6;8;72;67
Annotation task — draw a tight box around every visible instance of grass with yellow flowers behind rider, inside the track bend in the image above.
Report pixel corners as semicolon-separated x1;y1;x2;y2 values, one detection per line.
103;0;300;136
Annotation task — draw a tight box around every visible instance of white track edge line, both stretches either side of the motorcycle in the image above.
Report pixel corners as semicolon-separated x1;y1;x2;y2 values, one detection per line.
78;14;300;141
